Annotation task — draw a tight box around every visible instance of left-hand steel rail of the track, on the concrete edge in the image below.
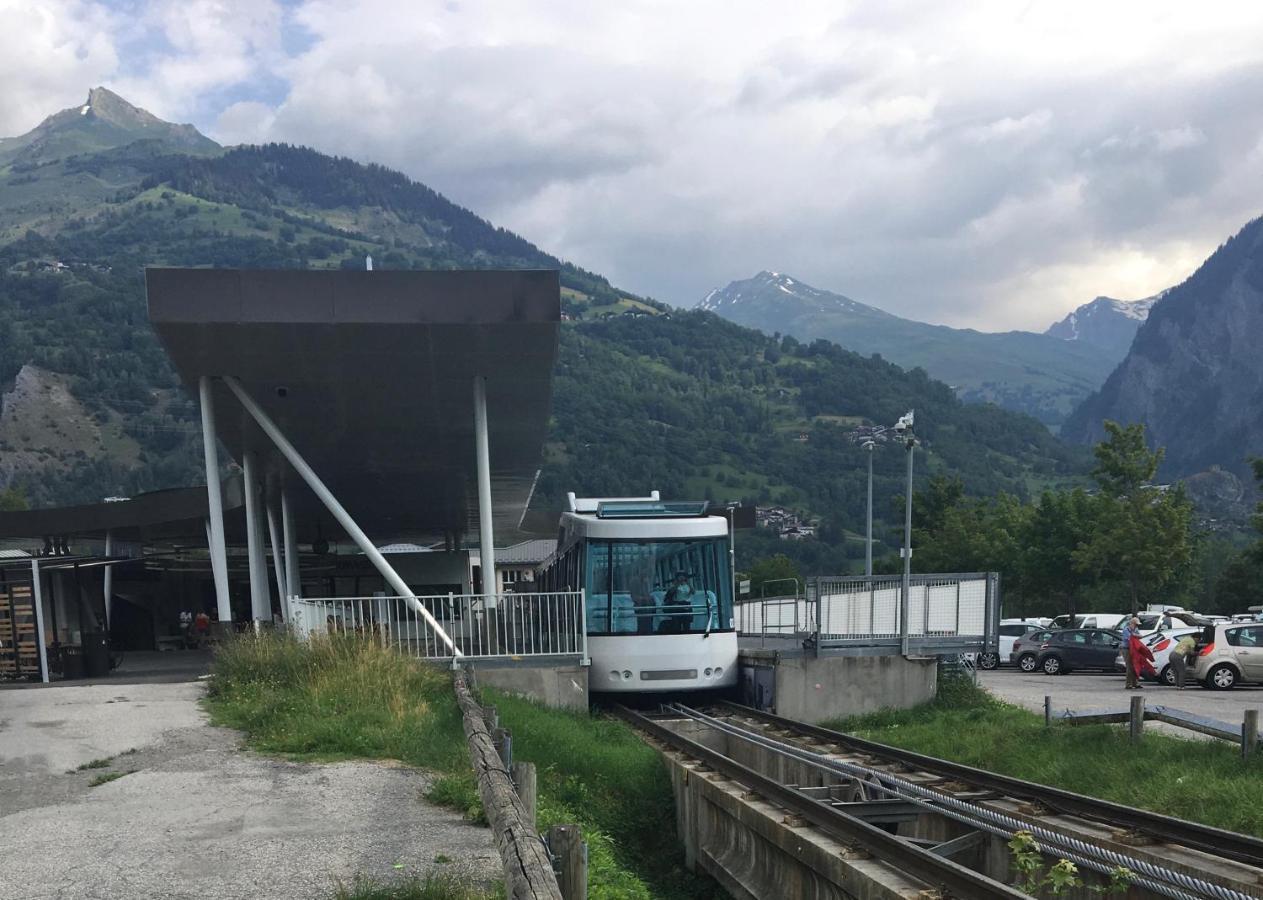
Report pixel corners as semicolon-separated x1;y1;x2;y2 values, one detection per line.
615;706;1028;900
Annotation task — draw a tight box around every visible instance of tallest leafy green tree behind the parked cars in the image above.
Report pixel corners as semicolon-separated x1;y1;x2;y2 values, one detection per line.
1072;422;1192;615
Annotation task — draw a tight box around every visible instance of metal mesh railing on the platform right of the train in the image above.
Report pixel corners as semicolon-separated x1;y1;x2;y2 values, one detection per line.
735;572;1000;653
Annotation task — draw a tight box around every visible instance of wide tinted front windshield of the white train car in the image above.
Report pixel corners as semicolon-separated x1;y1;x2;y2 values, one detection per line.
584;538;733;635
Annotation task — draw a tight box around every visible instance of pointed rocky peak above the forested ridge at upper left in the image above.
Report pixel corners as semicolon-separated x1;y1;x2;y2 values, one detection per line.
0;87;220;167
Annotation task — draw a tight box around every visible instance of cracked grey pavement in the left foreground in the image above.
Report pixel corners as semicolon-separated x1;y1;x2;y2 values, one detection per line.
0;682;500;900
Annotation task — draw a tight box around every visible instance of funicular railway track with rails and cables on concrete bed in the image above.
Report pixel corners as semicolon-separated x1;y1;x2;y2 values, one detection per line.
618;703;1263;900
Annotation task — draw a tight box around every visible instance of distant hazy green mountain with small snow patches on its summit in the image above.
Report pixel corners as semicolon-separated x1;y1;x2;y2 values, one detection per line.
697;271;1125;427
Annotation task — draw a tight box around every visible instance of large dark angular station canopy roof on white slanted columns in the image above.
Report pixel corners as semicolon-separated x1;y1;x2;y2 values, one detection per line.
145;269;561;544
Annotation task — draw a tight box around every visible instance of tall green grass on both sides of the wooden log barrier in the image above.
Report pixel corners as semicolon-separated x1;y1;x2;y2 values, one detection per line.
206;635;722;900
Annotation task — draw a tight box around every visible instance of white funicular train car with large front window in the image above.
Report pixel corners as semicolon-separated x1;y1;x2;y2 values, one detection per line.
539;491;736;693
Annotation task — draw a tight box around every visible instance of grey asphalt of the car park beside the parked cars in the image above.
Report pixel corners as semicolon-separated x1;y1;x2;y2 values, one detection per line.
978;668;1263;737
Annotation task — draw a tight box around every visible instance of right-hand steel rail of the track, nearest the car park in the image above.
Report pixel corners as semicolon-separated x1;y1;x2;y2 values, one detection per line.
719;701;1263;867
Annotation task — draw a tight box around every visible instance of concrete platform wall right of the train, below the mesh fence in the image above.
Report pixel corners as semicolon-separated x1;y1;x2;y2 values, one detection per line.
740;650;938;723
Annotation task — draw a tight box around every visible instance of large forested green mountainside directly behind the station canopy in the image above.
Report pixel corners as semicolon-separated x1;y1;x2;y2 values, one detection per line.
0;87;1086;568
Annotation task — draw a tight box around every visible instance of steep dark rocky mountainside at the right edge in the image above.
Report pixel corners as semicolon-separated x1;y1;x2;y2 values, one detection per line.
1062;218;1263;483
